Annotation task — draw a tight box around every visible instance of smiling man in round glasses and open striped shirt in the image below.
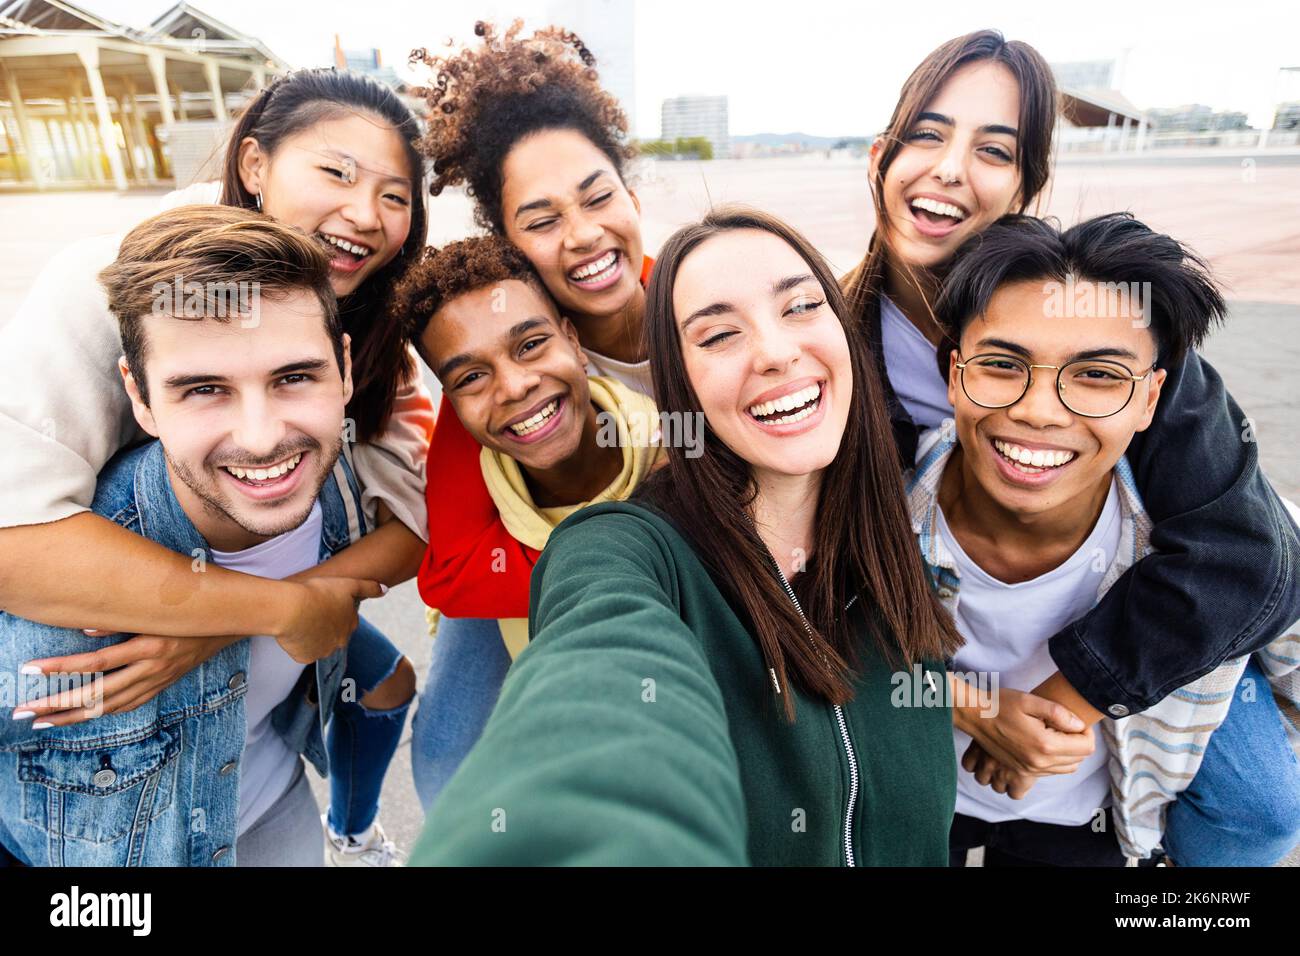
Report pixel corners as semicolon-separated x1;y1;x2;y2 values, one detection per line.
909;213;1300;866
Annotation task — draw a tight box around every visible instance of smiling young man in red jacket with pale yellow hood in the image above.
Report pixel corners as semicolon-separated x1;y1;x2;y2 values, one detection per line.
395;235;665;809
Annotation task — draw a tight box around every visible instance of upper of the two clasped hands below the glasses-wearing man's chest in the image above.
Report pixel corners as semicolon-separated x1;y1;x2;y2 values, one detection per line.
954;688;1097;777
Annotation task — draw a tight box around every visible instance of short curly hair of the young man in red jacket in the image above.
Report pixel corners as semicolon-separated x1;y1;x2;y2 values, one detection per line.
393;235;550;343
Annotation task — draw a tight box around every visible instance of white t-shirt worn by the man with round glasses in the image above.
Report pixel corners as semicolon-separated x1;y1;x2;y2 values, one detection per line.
937;479;1121;826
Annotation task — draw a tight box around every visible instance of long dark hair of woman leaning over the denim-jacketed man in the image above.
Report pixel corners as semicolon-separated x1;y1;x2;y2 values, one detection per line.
220;68;428;441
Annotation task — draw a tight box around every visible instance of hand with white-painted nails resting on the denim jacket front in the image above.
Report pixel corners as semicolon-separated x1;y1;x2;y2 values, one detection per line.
14;630;239;727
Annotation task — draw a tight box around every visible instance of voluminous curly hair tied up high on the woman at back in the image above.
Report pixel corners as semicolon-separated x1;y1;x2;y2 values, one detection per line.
411;20;636;234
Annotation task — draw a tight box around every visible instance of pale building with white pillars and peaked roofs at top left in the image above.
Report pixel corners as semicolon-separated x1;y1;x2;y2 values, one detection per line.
0;0;289;190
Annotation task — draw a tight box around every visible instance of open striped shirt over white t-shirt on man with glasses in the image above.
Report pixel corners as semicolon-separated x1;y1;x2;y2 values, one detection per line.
907;428;1300;858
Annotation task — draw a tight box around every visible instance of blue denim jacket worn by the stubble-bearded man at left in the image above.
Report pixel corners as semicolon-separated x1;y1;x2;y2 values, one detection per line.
0;441;365;866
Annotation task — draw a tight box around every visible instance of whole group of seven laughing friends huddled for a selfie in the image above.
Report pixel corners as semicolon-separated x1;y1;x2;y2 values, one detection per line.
0;23;1300;866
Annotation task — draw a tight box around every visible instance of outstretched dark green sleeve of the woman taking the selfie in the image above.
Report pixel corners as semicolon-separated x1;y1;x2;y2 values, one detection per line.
412;506;748;866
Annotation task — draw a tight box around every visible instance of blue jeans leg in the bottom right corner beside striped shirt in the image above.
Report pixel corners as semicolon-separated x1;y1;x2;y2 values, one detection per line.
1164;658;1300;866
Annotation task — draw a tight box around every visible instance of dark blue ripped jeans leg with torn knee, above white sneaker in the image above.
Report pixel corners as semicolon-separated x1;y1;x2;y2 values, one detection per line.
325;618;411;836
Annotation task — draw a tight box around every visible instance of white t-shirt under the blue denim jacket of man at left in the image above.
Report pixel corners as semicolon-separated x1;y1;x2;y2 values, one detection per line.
212;501;322;834
